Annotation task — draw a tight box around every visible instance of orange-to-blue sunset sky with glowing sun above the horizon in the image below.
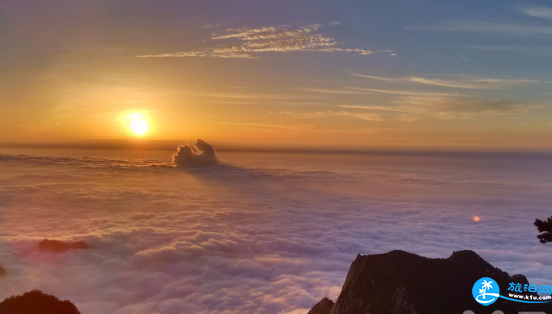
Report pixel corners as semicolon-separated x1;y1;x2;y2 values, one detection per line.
0;0;552;150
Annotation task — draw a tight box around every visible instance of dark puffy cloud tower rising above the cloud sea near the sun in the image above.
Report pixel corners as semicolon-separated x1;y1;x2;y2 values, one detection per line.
172;139;219;167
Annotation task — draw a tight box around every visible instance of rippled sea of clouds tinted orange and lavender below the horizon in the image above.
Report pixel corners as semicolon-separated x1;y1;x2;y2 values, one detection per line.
0;147;552;314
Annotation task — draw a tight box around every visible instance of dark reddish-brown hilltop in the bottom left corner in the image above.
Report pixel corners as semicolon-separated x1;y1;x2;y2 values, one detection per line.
0;290;80;314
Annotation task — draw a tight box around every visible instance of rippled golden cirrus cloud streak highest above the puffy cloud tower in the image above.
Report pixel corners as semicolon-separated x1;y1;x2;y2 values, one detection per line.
137;24;395;59
